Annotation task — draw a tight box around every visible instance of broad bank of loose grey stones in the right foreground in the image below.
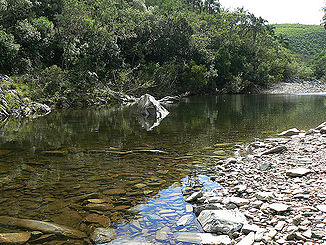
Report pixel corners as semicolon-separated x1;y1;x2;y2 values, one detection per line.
180;123;326;245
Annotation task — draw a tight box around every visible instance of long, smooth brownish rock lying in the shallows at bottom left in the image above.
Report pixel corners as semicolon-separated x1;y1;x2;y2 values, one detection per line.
0;216;87;238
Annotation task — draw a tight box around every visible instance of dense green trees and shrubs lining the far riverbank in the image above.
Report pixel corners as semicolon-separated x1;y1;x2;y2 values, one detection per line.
0;0;322;116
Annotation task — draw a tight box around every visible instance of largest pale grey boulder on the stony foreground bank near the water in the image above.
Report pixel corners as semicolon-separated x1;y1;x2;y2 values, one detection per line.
198;210;247;235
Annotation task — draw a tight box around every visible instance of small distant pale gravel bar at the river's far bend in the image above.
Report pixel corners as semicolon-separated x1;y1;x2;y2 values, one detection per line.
262;80;326;94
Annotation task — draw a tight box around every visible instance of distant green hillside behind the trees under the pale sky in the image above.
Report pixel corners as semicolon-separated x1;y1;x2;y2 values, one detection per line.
275;24;326;56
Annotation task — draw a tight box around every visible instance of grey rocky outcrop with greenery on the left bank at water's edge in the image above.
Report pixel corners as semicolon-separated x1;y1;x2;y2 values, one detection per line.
0;83;51;120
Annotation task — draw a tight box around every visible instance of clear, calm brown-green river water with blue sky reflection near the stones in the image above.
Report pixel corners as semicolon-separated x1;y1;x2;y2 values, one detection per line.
0;95;326;244
